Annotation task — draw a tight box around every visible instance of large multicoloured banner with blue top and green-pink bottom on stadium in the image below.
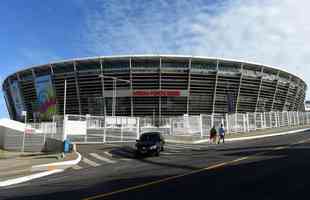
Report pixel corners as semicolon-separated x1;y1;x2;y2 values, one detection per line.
35;75;56;120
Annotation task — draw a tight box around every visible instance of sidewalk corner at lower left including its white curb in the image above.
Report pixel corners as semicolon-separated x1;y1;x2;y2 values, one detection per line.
0;150;81;187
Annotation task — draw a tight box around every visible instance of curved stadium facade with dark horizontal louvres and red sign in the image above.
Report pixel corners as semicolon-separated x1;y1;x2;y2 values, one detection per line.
3;55;307;121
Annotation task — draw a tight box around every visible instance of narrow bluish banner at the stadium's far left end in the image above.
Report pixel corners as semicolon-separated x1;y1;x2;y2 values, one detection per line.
10;81;25;120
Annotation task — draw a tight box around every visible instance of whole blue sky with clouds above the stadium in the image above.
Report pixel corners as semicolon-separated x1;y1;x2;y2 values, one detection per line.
0;0;310;117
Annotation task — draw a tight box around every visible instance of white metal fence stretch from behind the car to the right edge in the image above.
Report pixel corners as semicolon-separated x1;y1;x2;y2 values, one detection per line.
140;111;310;137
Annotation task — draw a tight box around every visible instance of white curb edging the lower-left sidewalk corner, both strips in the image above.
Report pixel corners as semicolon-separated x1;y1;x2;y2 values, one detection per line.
0;152;82;187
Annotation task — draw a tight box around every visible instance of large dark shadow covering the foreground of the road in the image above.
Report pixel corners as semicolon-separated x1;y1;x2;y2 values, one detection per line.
0;142;310;200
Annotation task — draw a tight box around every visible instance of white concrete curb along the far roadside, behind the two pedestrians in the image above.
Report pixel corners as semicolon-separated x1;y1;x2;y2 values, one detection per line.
166;128;310;144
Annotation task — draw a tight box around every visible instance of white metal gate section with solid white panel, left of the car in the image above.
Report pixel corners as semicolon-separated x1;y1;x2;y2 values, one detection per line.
64;115;139;143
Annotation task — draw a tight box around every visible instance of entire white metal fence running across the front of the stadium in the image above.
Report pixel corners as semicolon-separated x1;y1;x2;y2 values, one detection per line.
5;112;310;151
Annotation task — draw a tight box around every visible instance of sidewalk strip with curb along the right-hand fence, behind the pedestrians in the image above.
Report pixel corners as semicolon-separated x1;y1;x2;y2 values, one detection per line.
165;125;310;144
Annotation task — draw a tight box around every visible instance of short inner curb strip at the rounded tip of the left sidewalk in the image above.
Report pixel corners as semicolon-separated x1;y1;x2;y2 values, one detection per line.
31;152;82;171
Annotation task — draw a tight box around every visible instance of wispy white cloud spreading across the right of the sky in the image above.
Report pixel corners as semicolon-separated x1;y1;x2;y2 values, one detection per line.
85;0;310;97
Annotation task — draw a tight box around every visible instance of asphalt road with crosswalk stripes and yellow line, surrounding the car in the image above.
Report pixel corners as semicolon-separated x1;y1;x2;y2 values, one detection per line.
0;131;310;200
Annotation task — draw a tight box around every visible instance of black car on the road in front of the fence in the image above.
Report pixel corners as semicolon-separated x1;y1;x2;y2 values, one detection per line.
136;132;165;156
